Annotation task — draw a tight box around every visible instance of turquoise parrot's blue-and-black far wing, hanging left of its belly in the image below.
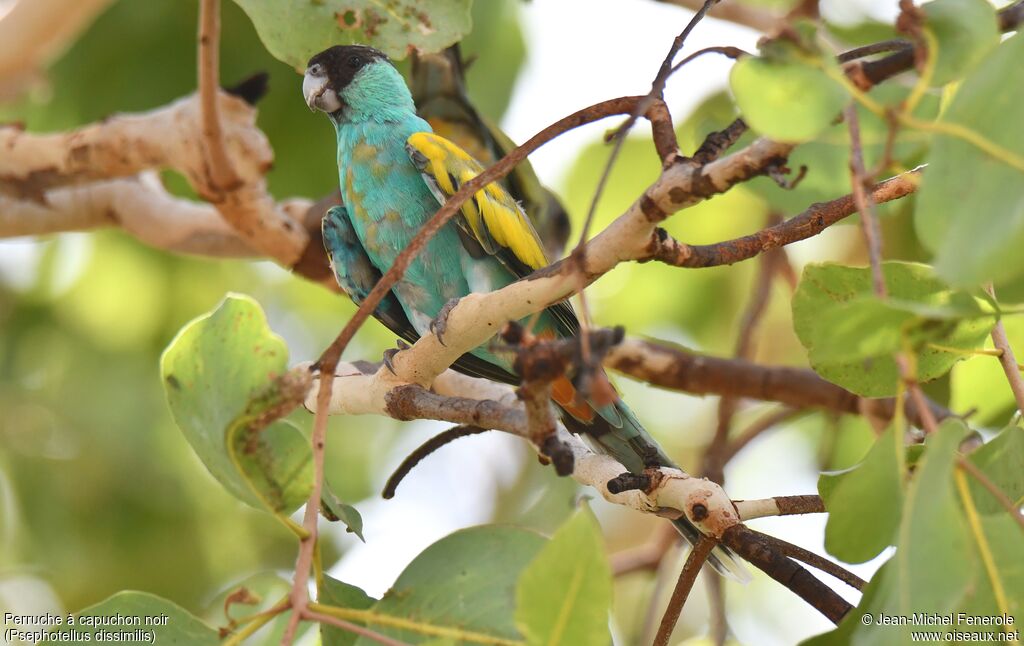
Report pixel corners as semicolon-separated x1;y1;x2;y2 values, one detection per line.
322;206;519;384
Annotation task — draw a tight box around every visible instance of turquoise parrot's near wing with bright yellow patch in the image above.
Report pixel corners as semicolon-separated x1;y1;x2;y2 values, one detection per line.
406;132;580;335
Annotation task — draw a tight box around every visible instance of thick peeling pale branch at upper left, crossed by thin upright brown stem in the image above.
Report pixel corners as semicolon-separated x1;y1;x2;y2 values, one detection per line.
0;92;309;267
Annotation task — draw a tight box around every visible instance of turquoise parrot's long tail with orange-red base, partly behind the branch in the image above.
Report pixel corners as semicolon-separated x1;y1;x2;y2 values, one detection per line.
552;378;751;583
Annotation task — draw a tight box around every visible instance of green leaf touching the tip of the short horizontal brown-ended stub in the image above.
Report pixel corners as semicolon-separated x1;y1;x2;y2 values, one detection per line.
818;427;903;563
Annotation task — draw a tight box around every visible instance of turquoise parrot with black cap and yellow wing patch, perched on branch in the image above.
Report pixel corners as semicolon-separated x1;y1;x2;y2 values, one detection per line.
302;45;745;579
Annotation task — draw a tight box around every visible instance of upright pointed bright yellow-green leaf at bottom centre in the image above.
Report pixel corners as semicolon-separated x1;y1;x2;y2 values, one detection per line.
515;508;611;644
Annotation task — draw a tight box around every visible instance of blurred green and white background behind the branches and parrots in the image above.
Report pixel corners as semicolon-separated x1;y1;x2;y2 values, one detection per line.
0;0;1024;644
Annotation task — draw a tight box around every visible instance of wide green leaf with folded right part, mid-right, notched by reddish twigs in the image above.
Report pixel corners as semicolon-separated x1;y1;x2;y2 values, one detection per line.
793;262;994;397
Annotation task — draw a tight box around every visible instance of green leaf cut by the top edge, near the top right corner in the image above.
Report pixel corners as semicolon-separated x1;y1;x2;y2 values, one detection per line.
921;0;999;85
